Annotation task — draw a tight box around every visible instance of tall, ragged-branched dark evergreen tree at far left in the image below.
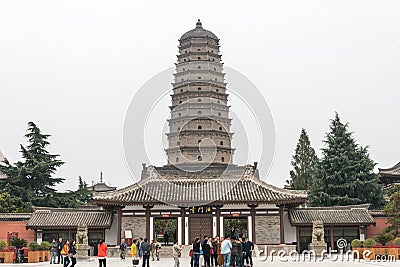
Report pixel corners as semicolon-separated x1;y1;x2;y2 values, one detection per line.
0;122;64;205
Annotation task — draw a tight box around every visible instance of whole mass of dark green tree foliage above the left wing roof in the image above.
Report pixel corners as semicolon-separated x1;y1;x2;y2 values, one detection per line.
0;122;91;212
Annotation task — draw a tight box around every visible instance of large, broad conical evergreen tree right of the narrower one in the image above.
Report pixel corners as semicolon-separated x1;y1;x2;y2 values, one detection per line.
310;113;383;207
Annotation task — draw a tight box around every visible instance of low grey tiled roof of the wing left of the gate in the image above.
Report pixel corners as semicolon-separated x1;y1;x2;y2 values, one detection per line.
26;208;112;228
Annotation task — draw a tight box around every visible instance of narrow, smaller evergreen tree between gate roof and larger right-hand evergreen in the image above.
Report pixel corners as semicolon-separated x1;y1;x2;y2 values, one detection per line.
286;129;318;190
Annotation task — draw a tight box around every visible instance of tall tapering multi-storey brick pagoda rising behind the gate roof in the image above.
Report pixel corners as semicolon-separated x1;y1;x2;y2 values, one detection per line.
166;20;233;165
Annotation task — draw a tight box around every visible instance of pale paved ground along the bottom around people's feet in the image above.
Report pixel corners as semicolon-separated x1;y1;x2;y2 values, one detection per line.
0;257;399;267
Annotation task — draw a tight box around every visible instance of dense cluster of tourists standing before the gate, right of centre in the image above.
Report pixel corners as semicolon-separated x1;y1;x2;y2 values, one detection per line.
189;236;254;267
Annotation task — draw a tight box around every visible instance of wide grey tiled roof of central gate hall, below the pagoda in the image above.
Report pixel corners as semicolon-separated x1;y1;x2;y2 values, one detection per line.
94;165;308;206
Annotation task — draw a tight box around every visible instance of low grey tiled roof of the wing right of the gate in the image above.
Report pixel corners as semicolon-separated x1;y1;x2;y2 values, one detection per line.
289;205;375;226
